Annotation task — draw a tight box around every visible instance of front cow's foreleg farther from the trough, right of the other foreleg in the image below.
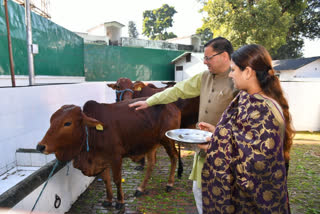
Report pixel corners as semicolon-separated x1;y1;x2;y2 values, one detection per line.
112;157;124;209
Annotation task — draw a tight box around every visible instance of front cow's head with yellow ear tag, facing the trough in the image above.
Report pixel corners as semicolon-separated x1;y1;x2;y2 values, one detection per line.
37;105;103;161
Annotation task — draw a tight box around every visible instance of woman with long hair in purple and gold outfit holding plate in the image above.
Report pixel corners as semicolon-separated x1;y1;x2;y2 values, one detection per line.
199;45;294;213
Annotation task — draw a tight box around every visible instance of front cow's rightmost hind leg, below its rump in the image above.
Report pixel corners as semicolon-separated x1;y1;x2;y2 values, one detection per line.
162;138;178;192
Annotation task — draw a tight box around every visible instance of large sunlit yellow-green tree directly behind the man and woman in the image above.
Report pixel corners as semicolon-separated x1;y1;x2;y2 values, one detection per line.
202;0;306;55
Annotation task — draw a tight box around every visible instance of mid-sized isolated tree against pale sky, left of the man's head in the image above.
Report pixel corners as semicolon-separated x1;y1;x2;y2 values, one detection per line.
142;4;177;40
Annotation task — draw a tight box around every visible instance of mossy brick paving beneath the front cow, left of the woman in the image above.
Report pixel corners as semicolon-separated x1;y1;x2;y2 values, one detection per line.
67;148;197;214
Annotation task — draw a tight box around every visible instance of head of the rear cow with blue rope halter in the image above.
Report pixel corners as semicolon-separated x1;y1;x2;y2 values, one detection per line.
107;78;133;102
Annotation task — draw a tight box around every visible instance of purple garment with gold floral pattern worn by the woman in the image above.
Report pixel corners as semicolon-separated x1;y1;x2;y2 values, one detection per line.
202;91;289;214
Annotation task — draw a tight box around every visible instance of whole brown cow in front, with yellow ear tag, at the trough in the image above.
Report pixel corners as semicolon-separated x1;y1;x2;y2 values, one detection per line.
37;98;180;209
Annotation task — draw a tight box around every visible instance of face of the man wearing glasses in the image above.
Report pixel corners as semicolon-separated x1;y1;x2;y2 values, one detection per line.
203;46;226;74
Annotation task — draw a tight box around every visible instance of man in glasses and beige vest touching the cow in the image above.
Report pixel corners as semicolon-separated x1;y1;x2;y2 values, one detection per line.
129;37;236;214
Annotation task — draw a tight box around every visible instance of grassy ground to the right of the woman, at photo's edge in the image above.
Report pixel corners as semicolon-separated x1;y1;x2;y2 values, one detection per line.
288;132;320;214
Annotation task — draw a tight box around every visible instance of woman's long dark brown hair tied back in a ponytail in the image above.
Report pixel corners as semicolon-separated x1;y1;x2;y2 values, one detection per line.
231;44;294;161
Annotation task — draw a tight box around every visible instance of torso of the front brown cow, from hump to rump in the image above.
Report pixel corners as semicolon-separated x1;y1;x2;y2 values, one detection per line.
83;98;181;156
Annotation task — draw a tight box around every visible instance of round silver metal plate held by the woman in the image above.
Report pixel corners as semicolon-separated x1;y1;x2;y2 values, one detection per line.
166;129;212;144
